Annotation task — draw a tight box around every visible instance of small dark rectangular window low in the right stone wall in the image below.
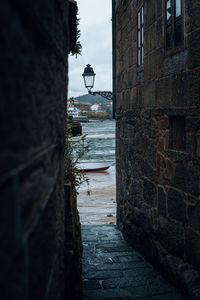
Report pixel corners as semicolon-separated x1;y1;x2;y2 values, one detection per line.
169;116;186;150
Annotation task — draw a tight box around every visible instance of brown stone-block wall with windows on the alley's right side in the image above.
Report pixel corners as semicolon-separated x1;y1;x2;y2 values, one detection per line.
116;0;200;299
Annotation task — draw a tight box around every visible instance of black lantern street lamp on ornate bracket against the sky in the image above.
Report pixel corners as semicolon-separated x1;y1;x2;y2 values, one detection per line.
82;64;112;100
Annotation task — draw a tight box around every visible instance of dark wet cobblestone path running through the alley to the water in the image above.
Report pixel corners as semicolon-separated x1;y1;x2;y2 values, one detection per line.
82;225;185;300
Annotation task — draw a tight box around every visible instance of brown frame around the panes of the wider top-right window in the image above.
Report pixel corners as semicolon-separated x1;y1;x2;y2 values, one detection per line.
163;0;184;54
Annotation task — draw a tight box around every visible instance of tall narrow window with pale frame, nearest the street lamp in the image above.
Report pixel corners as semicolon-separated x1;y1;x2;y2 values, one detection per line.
137;6;144;66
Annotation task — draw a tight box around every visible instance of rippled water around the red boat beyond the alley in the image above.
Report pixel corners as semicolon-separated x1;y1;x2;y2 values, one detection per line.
78;120;116;224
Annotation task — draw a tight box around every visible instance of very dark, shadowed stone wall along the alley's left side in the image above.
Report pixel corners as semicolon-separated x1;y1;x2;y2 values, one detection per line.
0;0;82;300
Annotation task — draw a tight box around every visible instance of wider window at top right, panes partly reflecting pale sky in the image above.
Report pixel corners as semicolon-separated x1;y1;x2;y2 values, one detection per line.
165;0;183;50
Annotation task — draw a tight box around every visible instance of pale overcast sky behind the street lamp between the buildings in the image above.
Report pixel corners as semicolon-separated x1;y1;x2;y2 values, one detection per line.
68;0;112;98
